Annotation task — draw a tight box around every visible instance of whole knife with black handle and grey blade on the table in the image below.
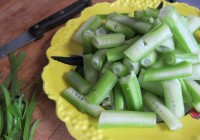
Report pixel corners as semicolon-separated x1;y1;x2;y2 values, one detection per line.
0;0;92;58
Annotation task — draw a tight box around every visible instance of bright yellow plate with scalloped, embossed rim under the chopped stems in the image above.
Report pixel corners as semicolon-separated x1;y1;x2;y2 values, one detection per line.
42;0;200;140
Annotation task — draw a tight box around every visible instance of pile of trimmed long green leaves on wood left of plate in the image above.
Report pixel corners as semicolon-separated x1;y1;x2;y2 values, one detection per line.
0;52;42;140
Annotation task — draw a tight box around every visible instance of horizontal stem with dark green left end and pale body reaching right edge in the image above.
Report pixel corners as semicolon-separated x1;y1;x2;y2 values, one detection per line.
163;52;200;65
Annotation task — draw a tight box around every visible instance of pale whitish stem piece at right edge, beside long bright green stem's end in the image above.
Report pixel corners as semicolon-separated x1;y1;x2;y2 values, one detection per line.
183;63;200;80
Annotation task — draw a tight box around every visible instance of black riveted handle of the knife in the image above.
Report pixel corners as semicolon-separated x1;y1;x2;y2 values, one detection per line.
28;0;91;39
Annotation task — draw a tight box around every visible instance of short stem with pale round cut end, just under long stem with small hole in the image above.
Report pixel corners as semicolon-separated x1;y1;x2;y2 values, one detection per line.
140;51;157;68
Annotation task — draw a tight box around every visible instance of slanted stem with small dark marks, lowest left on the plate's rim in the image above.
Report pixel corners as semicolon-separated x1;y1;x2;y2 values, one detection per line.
62;87;102;117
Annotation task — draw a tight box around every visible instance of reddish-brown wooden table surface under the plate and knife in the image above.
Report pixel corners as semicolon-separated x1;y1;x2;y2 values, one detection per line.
0;0;114;140
